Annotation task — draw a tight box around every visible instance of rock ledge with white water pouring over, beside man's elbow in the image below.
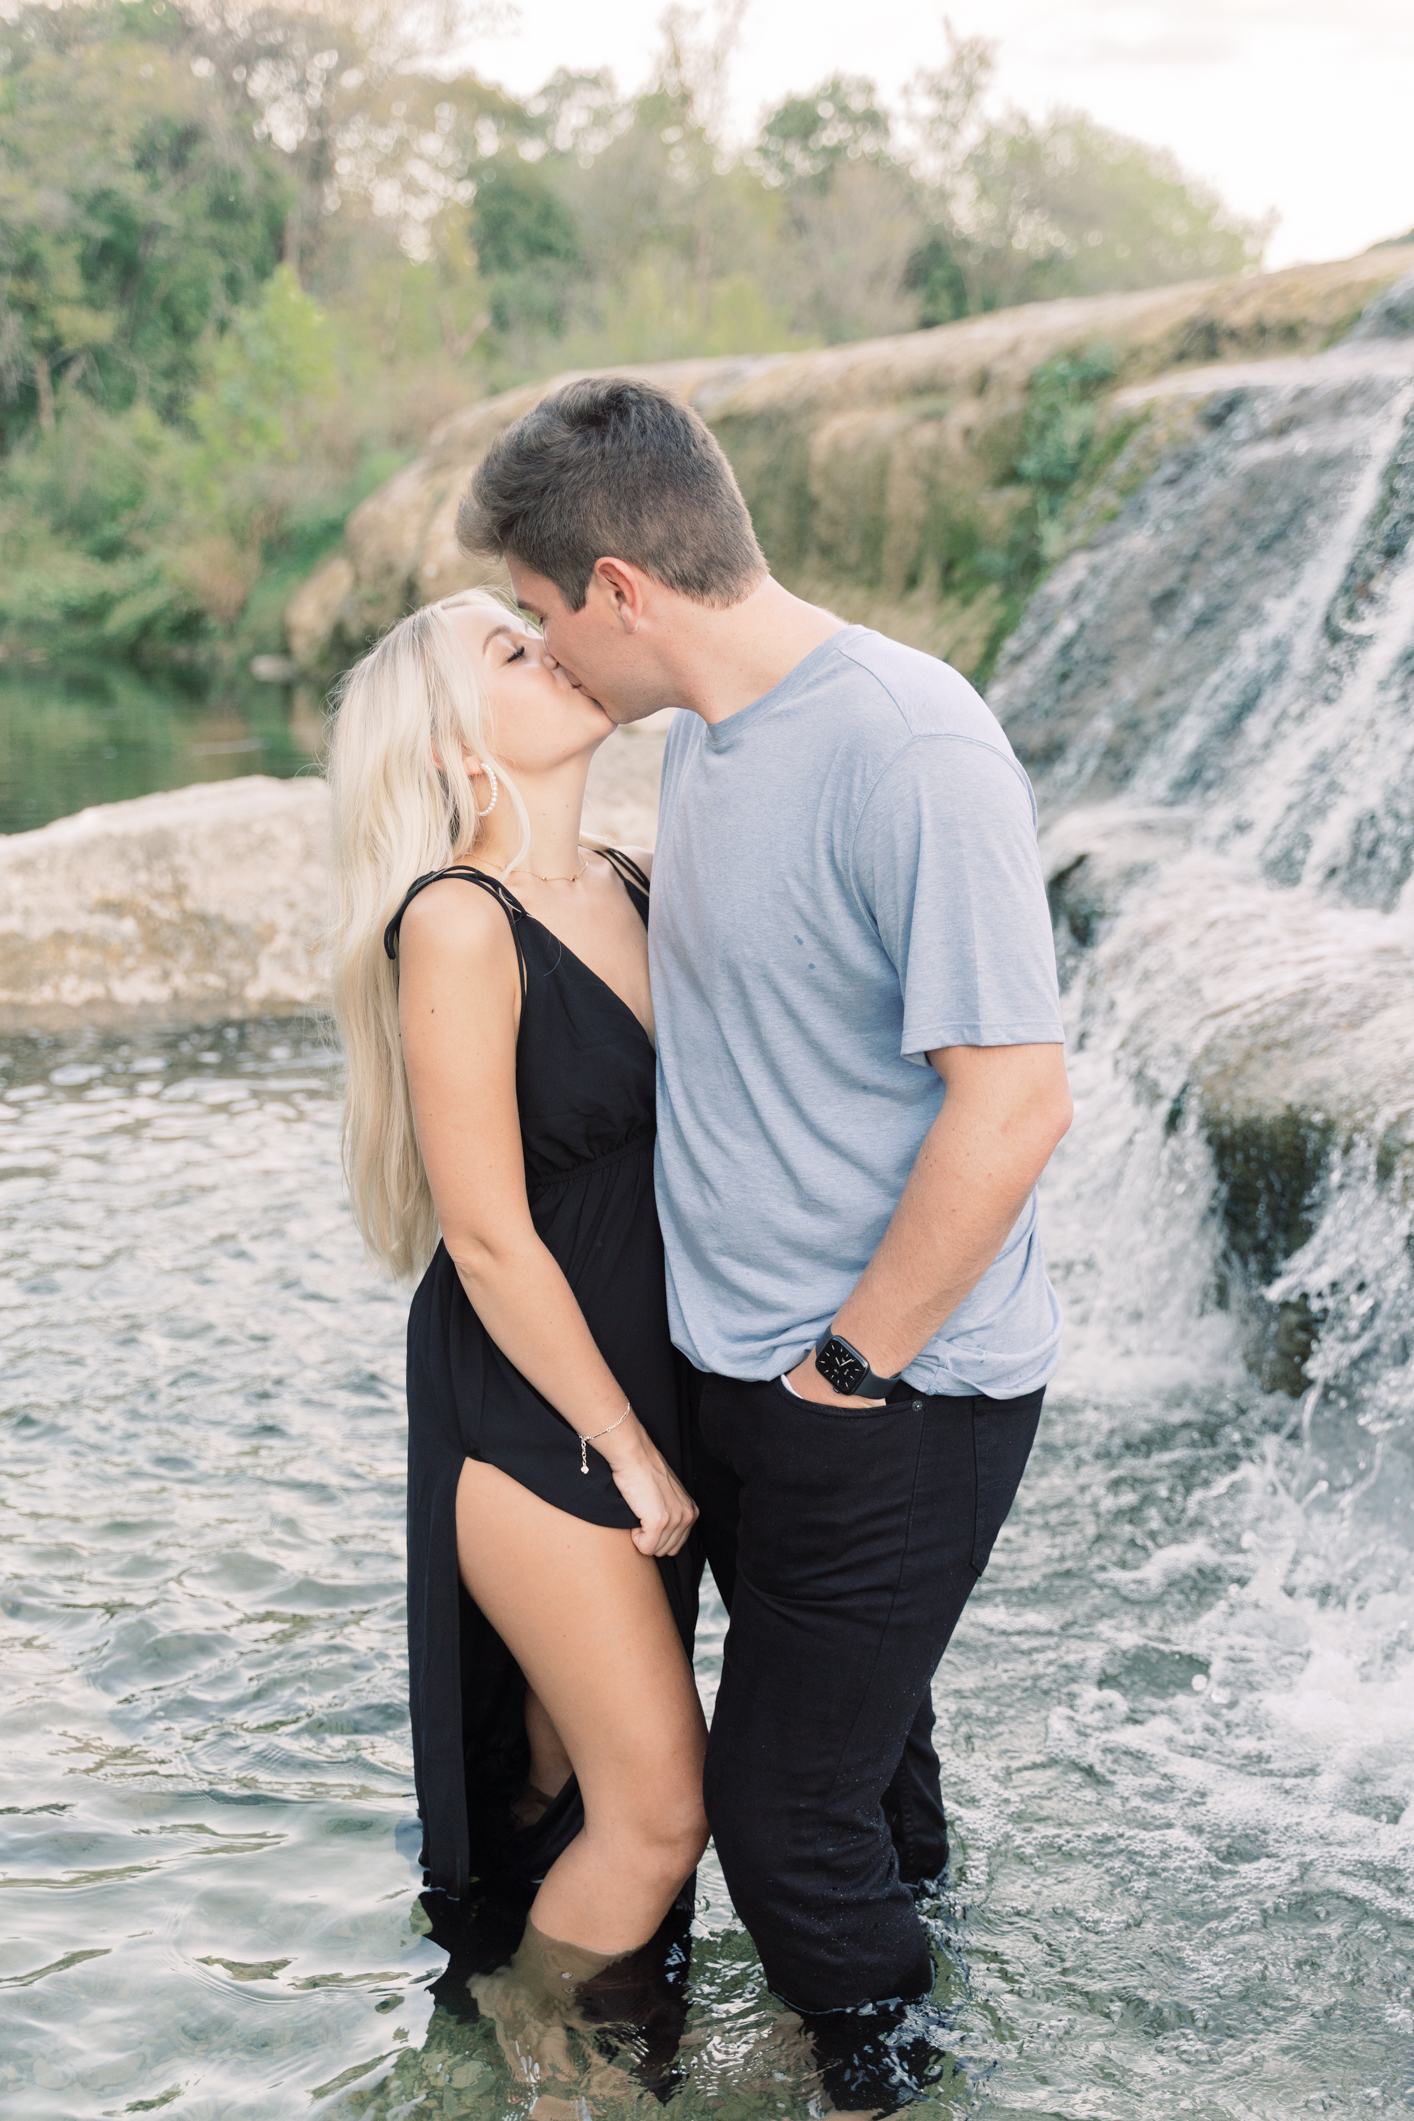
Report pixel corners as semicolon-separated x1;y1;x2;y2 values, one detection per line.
1043;802;1414;1398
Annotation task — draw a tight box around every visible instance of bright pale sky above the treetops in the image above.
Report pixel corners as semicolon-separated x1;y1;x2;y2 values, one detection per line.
471;0;1414;265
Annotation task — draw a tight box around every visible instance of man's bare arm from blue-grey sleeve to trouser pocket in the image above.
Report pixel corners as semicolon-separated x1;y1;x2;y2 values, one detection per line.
789;1046;1071;1406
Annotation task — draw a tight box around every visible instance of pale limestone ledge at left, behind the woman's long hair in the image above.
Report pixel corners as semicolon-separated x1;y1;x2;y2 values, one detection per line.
0;774;329;1033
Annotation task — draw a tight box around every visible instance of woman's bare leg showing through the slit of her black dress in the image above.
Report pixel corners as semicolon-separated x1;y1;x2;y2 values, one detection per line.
456;1459;706;1953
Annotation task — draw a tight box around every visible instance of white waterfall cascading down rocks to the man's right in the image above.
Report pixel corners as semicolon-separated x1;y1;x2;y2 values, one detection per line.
992;276;1414;1538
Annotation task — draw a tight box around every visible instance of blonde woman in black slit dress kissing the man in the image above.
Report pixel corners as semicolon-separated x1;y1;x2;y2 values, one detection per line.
329;592;706;1958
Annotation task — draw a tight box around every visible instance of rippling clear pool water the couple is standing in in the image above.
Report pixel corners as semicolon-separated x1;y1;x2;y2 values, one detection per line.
0;1001;1414;2121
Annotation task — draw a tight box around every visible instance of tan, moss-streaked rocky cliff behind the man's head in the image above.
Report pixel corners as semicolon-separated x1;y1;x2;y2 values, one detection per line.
286;248;1412;674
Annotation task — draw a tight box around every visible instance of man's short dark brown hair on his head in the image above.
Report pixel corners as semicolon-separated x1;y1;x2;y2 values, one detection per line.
456;375;765;611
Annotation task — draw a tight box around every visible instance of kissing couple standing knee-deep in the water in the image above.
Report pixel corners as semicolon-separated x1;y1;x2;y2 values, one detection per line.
329;378;1071;2087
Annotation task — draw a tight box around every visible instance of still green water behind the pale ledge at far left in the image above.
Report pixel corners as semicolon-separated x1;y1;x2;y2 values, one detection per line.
0;662;322;831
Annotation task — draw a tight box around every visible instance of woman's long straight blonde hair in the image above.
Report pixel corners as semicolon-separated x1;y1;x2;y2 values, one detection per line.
326;590;530;1277
